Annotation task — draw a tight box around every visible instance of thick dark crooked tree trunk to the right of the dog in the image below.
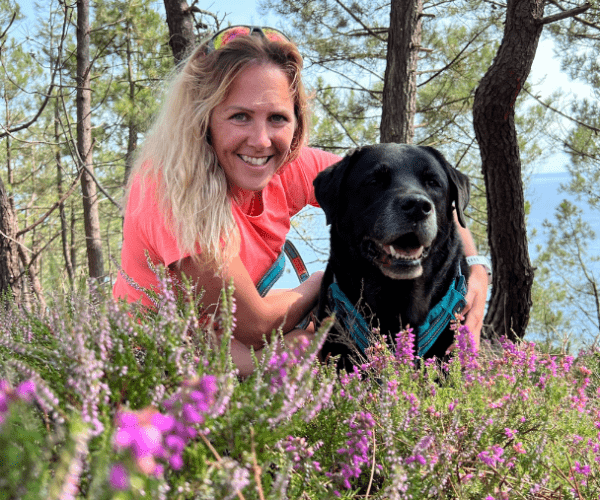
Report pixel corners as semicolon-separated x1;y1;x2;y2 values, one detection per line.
473;0;544;340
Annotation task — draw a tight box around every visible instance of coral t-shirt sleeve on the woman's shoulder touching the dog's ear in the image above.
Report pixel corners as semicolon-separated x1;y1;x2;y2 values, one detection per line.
281;148;341;216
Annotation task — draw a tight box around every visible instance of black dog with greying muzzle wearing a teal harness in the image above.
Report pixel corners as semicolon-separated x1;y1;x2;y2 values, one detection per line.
314;144;469;369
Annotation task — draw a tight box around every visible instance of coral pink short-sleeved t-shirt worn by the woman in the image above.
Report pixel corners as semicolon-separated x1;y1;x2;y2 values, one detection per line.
113;148;339;307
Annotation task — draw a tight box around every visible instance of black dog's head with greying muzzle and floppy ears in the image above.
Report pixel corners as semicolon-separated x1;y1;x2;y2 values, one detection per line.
314;144;469;279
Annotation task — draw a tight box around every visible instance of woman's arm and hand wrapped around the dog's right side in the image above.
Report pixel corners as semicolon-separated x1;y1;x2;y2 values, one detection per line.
454;212;488;349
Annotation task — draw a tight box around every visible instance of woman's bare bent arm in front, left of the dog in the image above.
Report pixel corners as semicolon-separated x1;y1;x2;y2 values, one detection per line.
170;256;323;349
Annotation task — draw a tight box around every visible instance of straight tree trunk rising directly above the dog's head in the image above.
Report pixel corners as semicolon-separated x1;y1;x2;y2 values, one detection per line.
380;0;423;144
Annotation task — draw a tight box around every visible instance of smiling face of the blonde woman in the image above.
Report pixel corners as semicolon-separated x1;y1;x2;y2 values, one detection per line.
210;64;296;195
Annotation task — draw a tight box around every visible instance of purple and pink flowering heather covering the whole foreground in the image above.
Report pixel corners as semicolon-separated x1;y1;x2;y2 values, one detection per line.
0;275;600;500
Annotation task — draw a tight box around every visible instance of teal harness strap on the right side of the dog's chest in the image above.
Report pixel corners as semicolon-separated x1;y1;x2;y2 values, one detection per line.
416;265;467;357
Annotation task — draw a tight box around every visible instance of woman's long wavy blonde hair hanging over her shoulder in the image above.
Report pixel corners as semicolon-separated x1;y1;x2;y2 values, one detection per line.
128;35;309;268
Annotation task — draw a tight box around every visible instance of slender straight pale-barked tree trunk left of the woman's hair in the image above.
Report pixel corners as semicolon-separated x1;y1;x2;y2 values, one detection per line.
77;0;104;278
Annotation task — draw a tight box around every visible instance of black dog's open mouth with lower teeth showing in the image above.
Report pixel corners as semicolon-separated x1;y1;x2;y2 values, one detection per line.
365;233;429;279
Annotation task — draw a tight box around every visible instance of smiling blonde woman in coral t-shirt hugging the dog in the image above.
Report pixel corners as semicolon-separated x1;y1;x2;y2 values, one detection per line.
114;26;487;376
